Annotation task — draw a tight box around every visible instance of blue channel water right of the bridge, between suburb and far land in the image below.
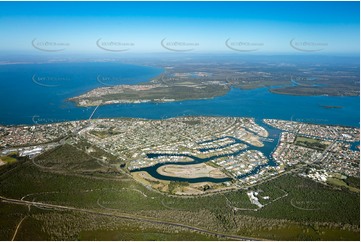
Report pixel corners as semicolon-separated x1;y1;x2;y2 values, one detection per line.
94;88;360;127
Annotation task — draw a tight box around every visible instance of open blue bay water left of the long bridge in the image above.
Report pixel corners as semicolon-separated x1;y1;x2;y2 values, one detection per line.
0;62;163;125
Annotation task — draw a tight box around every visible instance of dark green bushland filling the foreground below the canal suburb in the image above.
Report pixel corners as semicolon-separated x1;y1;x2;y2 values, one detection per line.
0;145;360;240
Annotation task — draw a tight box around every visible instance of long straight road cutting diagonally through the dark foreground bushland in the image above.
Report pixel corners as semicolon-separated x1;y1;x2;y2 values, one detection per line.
0;196;259;241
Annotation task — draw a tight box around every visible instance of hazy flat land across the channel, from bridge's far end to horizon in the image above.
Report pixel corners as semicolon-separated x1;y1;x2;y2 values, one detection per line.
68;58;360;107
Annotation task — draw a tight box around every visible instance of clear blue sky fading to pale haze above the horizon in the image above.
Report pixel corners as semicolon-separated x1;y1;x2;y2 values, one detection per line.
0;2;360;55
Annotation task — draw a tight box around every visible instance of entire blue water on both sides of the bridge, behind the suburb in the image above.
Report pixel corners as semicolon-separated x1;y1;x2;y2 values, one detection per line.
0;63;360;127
